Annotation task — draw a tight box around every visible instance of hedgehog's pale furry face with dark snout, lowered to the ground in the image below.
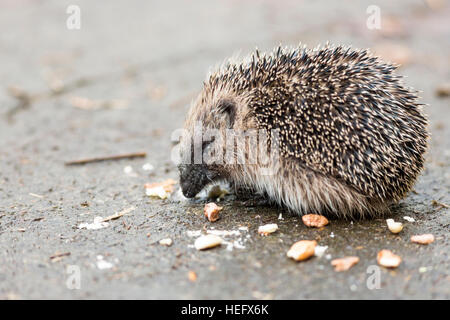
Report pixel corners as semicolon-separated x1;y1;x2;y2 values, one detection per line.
178;95;236;198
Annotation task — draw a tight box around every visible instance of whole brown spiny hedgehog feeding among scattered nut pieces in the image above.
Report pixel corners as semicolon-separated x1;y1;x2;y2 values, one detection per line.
178;43;429;218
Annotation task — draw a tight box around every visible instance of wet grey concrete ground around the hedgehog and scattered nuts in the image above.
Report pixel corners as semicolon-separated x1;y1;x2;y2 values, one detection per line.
0;0;450;299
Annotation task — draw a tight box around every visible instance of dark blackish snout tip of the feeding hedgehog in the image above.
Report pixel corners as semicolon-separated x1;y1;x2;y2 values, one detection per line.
179;164;211;198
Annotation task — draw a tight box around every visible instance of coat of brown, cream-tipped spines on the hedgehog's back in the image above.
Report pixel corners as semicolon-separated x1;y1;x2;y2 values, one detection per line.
184;43;429;218
